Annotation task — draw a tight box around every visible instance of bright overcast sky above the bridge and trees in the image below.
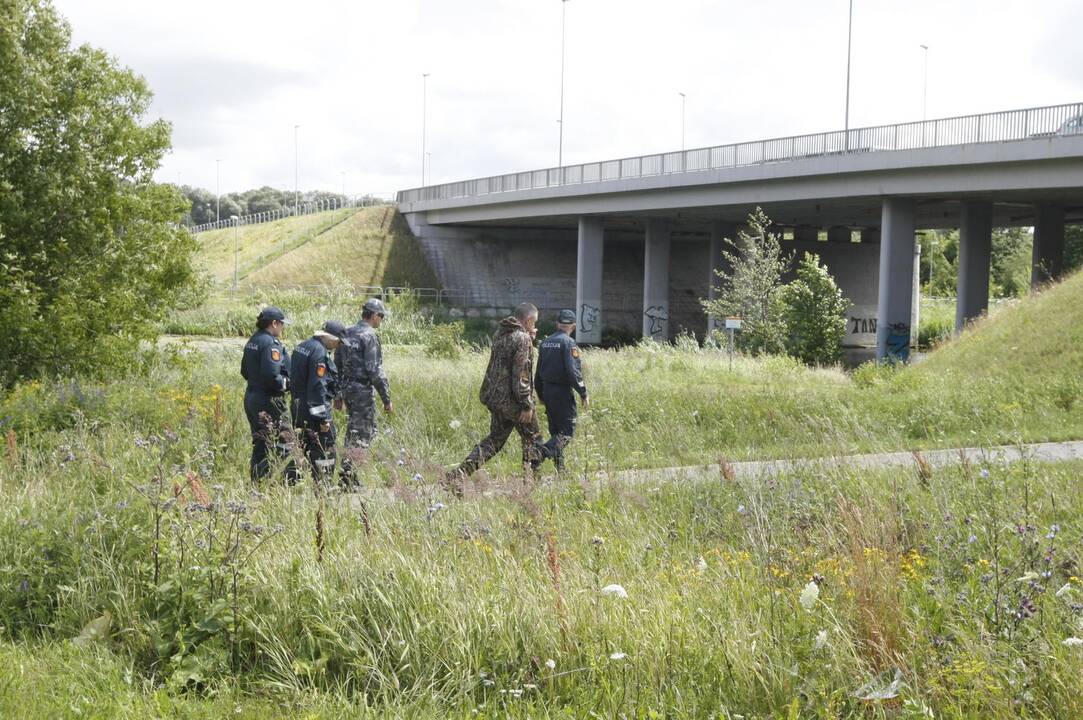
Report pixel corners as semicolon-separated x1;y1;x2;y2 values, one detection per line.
55;0;1083;194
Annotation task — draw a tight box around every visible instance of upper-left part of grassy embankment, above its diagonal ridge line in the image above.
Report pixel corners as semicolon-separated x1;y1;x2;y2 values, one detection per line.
196;209;358;285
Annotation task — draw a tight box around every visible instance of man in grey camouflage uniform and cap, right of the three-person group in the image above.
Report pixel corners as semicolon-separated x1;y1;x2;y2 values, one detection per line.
335;298;394;486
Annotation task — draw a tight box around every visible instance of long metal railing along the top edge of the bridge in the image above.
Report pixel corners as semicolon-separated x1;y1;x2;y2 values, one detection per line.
395;103;1083;202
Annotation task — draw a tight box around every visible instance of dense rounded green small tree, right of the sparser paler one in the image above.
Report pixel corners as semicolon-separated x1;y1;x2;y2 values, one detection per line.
782;252;850;365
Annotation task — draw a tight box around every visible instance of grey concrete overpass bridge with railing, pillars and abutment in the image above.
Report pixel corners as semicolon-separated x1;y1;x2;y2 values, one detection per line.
397;103;1083;357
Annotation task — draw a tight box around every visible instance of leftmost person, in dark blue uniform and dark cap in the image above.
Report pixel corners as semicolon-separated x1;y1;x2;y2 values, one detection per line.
240;306;297;483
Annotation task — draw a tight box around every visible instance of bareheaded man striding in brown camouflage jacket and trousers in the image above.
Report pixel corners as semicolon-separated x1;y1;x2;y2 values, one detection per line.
444;303;544;494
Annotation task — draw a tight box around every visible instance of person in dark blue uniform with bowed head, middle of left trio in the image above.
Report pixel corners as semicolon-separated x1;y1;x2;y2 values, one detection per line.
289;320;345;482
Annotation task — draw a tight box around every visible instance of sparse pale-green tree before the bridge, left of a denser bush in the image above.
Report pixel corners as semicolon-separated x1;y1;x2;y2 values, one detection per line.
701;208;793;353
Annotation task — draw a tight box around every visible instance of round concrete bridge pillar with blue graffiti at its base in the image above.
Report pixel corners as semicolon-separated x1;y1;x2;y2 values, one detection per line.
876;197;914;361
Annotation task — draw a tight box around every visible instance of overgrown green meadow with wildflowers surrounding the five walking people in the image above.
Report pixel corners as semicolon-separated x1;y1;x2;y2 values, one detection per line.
6;256;1083;718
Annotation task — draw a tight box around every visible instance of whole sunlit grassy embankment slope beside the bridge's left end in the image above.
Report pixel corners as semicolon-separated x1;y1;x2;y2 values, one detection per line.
196;206;439;290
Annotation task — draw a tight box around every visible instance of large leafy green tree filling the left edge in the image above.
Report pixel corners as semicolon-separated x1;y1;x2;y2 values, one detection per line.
0;0;195;385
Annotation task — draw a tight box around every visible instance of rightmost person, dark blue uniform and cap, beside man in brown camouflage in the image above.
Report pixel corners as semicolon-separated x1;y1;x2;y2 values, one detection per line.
534;310;590;472
